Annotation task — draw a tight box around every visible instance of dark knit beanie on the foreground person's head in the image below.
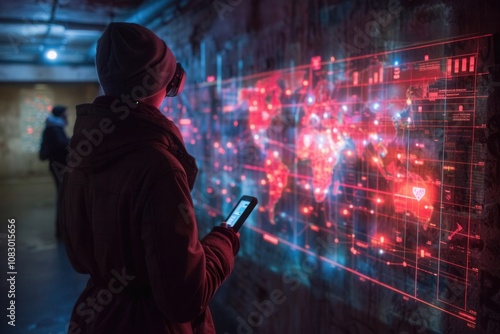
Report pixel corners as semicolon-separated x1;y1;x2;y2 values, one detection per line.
96;22;177;100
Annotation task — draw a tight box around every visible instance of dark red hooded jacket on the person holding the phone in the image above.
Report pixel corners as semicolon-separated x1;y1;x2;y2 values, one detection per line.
59;96;239;334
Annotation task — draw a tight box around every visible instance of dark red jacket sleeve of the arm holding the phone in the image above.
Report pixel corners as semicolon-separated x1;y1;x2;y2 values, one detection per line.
142;170;239;323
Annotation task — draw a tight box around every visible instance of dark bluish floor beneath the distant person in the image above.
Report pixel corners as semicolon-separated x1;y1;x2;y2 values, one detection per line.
0;175;236;334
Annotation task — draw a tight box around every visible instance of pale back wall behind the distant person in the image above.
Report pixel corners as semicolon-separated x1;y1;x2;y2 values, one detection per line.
0;83;98;178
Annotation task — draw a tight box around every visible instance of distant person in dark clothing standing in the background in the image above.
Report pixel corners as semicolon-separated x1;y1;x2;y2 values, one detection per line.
39;106;69;238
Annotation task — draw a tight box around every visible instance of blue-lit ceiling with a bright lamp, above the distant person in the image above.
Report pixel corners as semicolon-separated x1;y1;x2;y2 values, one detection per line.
0;0;189;66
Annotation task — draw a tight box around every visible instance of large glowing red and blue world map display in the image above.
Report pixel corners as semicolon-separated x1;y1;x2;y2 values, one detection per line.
164;36;489;330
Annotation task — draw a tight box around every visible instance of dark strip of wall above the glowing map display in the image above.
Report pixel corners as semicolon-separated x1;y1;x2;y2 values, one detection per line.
156;0;500;82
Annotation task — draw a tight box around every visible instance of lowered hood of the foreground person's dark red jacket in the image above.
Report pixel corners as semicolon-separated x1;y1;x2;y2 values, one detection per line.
68;96;198;188
